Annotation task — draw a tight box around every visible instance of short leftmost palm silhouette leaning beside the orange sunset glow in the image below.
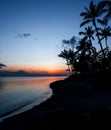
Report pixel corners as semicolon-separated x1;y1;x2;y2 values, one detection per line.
58;49;72;74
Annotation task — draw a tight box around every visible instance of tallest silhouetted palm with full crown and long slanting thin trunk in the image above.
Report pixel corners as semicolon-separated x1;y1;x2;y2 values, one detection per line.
80;1;106;57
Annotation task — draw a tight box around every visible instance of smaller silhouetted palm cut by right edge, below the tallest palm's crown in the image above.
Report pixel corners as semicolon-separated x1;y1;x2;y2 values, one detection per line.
99;26;111;51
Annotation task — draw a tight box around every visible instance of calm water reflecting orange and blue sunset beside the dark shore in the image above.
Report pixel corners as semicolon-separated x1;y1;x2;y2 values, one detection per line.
0;77;65;121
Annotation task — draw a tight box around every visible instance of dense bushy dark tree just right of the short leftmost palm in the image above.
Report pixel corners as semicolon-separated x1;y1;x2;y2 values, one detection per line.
76;37;97;73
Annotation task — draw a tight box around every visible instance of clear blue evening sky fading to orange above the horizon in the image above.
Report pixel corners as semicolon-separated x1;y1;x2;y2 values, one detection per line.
0;0;105;73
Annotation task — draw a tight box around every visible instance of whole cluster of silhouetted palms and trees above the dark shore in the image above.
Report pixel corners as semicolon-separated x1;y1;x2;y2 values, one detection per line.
58;1;111;74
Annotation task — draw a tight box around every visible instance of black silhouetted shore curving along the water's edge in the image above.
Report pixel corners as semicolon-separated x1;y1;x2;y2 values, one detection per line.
0;74;111;130
